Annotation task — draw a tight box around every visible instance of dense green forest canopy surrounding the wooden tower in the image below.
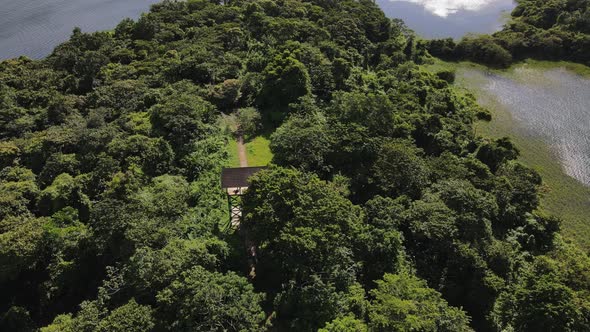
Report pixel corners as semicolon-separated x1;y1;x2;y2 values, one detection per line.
0;0;590;332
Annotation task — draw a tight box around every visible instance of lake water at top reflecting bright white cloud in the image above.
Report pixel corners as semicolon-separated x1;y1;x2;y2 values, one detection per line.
377;0;516;38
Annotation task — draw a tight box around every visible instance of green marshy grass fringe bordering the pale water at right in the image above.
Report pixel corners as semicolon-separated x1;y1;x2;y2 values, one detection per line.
427;60;590;249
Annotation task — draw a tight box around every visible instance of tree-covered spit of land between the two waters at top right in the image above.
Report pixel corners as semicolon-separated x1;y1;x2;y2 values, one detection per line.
427;0;590;67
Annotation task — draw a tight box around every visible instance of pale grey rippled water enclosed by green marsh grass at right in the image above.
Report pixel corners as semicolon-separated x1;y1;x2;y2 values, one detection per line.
459;67;590;185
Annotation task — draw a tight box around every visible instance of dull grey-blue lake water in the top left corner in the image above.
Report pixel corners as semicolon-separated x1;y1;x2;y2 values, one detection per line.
0;0;159;59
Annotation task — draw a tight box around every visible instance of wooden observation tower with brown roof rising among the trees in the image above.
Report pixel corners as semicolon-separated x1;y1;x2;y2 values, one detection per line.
221;167;266;228
